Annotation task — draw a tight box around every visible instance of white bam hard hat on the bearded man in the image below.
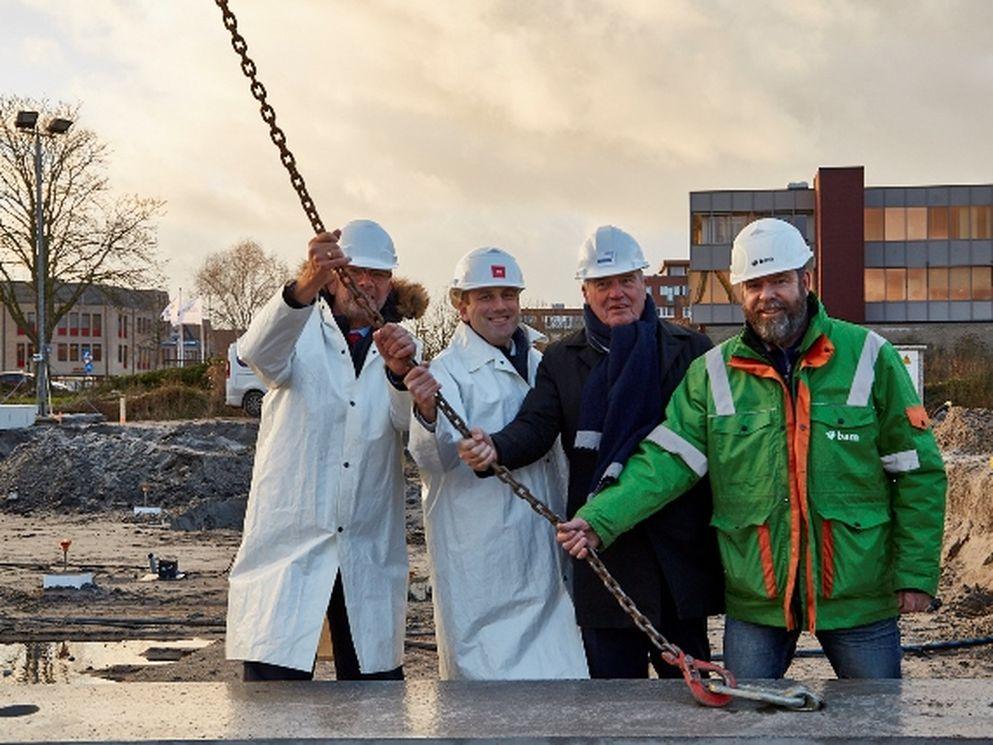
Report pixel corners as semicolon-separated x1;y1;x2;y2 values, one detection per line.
731;217;814;285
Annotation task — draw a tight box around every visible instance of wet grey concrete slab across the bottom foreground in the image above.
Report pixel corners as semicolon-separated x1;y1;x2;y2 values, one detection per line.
0;679;993;745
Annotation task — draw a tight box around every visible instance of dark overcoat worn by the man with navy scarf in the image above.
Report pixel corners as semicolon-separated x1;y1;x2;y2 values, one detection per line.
493;320;724;628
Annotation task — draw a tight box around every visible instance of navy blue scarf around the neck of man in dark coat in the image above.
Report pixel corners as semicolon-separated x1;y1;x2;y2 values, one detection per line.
575;295;663;494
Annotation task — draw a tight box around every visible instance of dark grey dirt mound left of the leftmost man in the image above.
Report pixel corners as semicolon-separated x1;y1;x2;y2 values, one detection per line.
0;420;258;513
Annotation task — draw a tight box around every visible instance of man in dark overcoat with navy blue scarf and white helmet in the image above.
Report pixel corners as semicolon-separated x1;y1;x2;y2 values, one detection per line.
459;226;723;678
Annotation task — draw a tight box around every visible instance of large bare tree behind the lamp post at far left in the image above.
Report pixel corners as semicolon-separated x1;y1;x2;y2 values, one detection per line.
0;96;164;347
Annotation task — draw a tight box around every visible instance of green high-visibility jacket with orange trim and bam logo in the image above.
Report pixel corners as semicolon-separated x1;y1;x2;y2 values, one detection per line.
578;297;947;631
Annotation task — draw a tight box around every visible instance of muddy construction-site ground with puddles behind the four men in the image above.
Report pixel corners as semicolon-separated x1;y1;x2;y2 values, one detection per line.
0;408;993;683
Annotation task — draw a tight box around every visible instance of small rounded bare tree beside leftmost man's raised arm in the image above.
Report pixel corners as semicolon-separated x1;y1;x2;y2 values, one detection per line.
196;240;290;330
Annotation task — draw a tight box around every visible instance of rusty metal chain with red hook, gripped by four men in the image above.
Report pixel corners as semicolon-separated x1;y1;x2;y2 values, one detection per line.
214;0;821;710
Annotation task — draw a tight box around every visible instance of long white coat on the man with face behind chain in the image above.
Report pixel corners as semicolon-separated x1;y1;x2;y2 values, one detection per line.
227;292;411;673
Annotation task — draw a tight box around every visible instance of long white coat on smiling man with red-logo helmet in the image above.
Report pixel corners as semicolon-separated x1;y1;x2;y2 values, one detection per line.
409;324;589;680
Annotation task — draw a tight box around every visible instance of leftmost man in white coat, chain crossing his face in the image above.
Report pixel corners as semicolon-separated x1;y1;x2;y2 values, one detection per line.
227;220;427;680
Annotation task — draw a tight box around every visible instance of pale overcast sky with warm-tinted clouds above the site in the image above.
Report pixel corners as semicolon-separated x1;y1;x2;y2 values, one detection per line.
0;0;993;303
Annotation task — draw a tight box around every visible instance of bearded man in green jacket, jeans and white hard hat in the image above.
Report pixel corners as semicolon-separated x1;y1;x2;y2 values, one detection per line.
558;218;946;678
